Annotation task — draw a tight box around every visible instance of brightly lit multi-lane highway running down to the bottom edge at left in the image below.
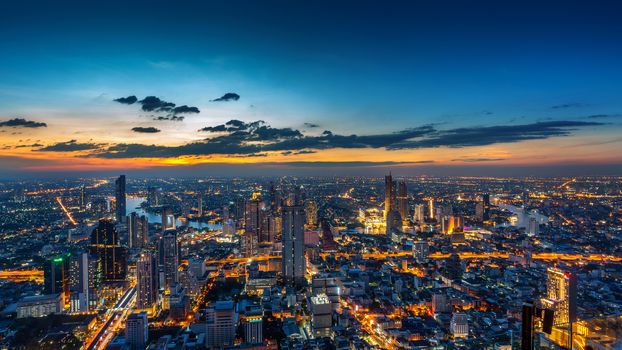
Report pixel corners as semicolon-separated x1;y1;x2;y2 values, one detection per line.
82;287;136;350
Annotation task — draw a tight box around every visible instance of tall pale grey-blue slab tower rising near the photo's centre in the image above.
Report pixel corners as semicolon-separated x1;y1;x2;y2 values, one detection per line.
282;205;305;284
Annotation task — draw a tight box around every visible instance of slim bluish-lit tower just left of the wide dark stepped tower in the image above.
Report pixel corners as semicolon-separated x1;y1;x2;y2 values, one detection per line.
69;252;93;312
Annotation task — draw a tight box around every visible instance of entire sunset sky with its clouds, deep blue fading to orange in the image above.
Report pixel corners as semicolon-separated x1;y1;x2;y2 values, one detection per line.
0;0;622;178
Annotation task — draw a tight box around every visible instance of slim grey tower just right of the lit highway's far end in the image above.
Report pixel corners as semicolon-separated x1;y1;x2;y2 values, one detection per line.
136;252;159;309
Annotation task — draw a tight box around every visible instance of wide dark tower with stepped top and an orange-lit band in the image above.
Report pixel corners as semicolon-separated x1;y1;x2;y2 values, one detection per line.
89;219;127;282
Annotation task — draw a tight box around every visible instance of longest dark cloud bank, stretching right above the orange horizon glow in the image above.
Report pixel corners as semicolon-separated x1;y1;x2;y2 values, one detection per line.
93;120;603;158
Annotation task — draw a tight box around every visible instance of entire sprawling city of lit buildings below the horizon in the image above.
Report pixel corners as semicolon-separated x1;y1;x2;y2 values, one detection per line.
0;174;622;349
